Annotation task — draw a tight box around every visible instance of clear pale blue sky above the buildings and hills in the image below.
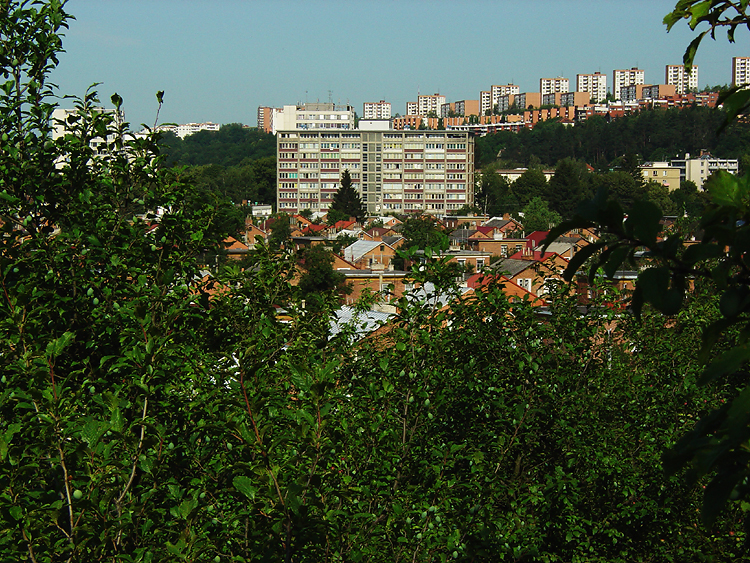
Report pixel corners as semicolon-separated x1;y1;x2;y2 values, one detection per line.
53;0;750;126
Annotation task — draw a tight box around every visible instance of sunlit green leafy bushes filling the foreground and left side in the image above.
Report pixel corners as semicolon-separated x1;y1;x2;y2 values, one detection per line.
0;2;744;563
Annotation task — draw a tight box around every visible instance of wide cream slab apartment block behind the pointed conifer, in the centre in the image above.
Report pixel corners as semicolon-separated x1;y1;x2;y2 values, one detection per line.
276;130;474;215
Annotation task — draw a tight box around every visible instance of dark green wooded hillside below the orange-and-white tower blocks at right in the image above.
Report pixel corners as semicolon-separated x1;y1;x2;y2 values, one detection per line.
476;107;750;170
